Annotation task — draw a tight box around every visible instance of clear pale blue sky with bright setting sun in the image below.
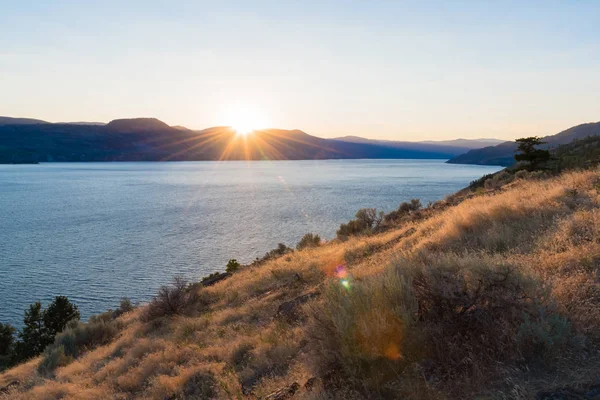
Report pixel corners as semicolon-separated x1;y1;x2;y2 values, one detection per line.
0;0;600;140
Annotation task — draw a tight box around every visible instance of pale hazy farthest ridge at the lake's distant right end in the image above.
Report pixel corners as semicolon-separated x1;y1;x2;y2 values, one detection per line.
335;136;502;158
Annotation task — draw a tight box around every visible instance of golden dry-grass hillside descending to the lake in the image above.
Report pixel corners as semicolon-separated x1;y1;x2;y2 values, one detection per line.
0;171;600;399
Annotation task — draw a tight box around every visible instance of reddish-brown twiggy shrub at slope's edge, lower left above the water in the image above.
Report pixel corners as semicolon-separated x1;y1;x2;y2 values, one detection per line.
142;276;202;321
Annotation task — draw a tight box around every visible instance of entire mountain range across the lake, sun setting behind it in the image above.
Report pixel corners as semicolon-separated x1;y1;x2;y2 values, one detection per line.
0;117;502;163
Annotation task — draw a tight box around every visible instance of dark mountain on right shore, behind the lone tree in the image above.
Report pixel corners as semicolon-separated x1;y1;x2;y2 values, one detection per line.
448;122;600;166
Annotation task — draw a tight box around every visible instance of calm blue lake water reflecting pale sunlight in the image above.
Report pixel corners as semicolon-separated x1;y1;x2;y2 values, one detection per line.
0;160;500;326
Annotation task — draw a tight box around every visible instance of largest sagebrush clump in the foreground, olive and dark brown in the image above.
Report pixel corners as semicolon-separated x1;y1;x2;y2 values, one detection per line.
311;254;568;397
